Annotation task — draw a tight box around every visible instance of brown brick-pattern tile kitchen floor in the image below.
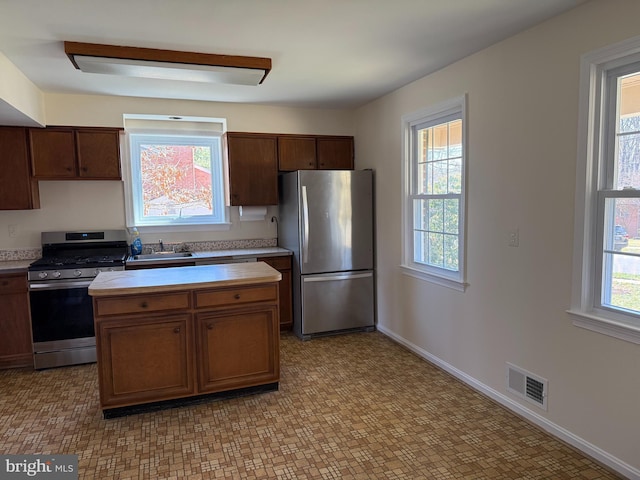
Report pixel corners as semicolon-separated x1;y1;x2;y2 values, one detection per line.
0;332;618;480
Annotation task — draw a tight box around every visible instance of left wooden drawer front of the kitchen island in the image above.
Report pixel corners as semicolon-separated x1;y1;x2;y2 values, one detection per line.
94;292;190;316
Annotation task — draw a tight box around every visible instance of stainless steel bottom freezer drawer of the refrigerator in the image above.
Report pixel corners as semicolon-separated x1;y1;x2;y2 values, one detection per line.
295;271;374;339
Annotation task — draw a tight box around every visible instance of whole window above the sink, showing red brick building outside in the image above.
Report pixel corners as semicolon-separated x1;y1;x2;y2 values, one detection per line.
126;116;226;229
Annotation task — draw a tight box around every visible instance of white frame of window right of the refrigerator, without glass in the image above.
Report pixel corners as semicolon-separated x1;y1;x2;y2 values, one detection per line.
400;94;468;292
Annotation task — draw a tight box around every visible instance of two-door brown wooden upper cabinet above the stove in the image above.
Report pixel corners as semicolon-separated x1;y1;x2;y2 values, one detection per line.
29;127;121;180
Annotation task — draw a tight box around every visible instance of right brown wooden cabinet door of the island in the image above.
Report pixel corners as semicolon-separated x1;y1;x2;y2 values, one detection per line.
195;305;280;393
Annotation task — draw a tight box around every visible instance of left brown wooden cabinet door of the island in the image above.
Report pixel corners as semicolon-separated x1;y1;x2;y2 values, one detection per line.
97;314;195;407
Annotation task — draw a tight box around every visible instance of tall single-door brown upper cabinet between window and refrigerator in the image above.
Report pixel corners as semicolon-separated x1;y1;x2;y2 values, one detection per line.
223;132;278;206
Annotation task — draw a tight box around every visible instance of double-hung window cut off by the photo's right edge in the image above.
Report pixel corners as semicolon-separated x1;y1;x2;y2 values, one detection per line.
571;40;640;343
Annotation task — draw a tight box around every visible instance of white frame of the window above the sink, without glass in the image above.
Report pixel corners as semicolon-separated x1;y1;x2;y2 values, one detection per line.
122;130;230;232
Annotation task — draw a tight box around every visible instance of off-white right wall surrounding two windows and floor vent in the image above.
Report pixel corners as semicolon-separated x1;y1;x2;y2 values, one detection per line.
356;0;640;472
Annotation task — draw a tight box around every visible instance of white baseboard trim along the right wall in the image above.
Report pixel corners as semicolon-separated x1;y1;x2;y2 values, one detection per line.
376;324;640;480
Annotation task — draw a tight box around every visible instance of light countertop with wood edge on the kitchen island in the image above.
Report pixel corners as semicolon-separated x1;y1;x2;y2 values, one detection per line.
89;262;282;297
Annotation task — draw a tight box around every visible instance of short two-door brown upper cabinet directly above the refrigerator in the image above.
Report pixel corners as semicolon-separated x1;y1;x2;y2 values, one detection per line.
278;135;353;172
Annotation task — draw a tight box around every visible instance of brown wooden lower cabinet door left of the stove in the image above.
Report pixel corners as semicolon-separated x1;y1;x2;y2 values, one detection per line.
0;273;33;368
